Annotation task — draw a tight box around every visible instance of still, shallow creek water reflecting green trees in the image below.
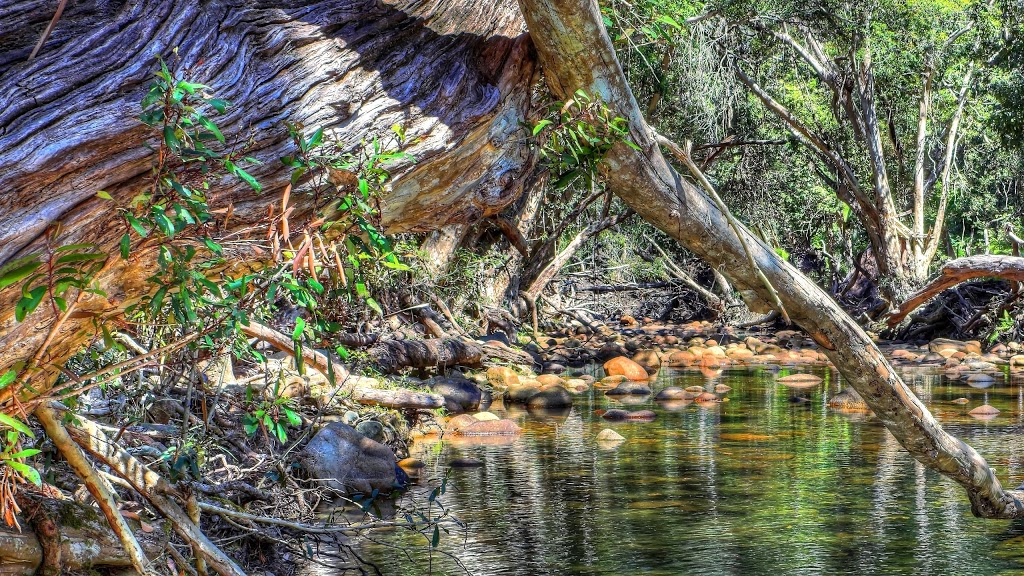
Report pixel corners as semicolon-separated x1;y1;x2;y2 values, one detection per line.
342;360;1024;576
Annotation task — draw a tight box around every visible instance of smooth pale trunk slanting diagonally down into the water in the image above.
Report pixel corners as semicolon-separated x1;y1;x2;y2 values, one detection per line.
519;0;1024;518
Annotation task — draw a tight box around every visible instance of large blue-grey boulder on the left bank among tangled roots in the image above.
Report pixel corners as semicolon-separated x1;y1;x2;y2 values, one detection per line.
299;422;396;493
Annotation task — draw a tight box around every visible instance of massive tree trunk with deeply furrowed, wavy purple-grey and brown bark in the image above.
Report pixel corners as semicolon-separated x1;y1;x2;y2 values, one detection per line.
0;0;535;389
